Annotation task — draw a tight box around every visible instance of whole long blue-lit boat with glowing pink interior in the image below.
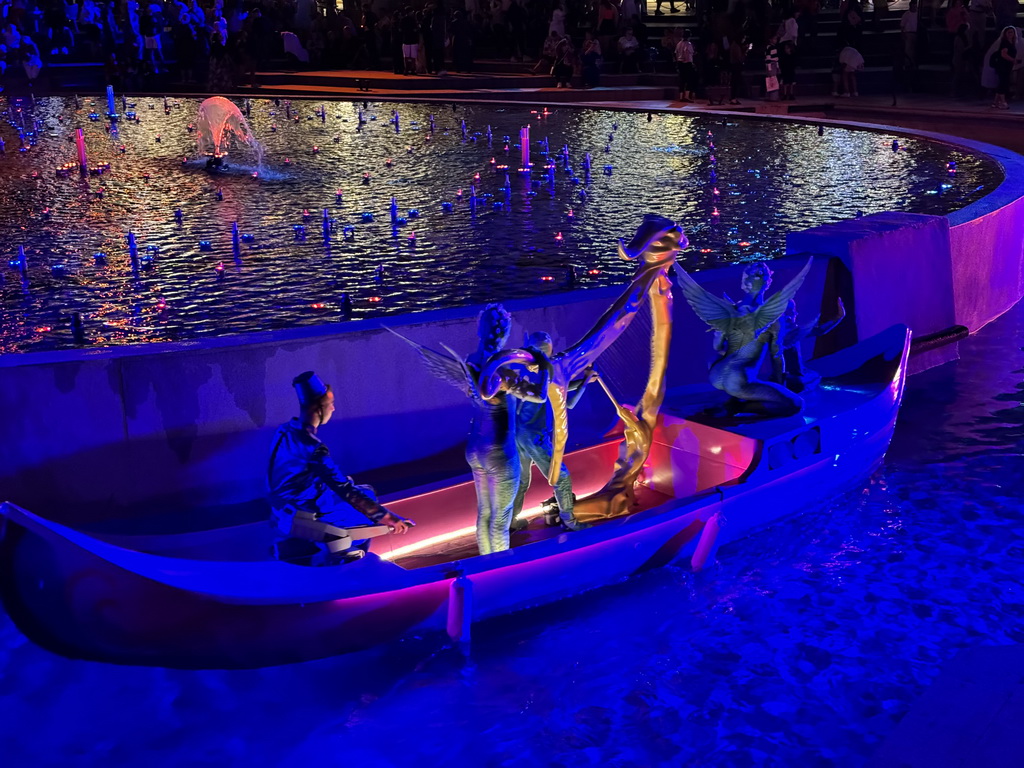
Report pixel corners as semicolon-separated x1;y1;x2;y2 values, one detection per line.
0;326;910;669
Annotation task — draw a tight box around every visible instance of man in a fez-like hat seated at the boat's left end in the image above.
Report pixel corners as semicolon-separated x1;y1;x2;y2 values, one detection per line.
267;371;413;559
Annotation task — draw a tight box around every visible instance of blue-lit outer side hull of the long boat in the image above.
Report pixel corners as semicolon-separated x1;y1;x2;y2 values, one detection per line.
0;329;909;669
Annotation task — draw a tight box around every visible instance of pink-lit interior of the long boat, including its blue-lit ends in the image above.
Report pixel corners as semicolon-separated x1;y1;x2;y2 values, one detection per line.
88;327;902;569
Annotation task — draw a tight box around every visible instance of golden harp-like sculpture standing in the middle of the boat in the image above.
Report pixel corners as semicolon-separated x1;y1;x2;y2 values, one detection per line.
479;214;688;520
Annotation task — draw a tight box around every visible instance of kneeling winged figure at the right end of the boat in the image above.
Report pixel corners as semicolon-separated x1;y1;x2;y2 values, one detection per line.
676;259;812;416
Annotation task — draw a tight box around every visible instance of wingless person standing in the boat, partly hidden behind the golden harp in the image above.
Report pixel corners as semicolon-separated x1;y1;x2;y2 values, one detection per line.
512;331;595;530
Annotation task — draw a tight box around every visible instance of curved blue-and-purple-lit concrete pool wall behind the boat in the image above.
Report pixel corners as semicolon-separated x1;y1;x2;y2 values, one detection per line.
0;118;1024;524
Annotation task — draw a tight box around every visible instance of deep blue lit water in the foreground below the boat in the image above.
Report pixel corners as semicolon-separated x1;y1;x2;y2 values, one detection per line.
0;305;1024;768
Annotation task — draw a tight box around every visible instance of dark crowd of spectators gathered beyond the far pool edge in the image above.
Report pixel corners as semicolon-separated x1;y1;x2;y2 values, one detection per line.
0;0;1024;106
